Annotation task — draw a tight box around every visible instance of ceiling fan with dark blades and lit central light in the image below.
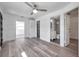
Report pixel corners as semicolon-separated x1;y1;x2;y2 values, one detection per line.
25;2;47;15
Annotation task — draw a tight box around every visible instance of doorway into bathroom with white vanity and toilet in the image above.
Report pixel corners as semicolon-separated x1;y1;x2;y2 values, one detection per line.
50;16;60;44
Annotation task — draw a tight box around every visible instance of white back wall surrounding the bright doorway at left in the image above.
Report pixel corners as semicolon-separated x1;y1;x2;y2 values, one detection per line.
2;11;36;41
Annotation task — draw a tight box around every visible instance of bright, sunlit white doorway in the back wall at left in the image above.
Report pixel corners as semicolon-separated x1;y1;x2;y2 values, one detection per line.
16;21;24;38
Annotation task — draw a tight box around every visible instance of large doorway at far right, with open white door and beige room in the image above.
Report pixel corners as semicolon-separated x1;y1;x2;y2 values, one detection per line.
65;8;78;53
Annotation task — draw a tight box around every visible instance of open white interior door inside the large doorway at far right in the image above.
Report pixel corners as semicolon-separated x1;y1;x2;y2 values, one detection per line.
64;14;70;46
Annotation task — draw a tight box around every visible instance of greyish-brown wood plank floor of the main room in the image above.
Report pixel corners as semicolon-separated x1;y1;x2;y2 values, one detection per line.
0;38;77;57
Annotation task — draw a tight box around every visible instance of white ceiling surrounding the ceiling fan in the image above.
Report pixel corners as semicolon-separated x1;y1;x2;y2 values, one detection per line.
0;2;70;18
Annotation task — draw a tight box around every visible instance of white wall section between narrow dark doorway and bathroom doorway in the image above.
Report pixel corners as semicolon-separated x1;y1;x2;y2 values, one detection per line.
40;17;50;42
